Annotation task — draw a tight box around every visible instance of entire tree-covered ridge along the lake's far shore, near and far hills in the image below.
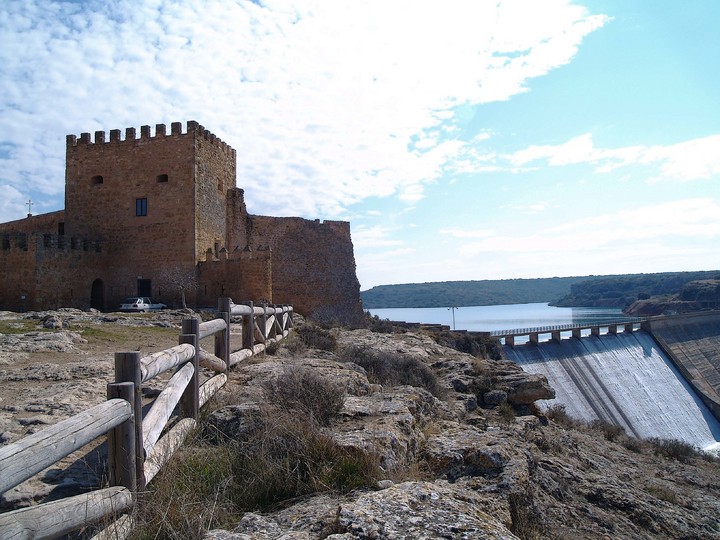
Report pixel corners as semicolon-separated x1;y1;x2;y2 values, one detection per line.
360;270;720;309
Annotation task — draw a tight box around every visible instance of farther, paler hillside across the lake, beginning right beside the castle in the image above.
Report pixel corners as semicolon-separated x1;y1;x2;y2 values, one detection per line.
360;277;590;309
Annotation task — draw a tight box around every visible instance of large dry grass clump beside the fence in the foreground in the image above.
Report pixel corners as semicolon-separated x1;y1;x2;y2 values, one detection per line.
132;408;383;539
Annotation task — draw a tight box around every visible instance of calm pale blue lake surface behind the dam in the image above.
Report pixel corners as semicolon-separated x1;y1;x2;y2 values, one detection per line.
368;304;627;332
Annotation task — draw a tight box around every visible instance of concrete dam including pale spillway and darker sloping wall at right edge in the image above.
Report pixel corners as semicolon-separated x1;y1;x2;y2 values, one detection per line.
504;315;720;452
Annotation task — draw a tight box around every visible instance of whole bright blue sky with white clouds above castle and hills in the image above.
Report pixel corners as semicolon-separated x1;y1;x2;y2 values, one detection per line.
0;0;720;289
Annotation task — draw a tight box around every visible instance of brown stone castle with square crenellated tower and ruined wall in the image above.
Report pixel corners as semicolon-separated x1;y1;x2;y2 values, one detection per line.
0;121;362;322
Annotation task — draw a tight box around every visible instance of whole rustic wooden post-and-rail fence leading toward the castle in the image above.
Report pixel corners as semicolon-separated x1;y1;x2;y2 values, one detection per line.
0;298;293;539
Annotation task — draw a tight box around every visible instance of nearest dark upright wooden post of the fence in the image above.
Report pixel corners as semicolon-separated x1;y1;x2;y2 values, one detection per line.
107;382;137;493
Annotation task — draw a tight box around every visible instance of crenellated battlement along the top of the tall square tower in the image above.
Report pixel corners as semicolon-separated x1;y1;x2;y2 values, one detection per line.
65;120;235;157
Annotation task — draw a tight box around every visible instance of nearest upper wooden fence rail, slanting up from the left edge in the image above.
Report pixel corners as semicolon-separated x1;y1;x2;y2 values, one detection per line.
0;399;133;493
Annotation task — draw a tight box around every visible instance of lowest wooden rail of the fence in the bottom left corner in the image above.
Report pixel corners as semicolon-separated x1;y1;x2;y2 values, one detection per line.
0;486;134;540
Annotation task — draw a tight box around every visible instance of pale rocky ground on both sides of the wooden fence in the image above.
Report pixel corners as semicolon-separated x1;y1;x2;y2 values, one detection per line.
0;311;720;540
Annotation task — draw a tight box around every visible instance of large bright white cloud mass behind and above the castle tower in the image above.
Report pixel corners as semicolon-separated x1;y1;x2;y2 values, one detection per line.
0;0;607;219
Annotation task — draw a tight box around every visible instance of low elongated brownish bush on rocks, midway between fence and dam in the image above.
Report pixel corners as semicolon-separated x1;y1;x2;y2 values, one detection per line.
341;346;445;398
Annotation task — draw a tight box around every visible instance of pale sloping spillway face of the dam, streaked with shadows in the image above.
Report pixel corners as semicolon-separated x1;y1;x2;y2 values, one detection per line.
504;331;720;450
